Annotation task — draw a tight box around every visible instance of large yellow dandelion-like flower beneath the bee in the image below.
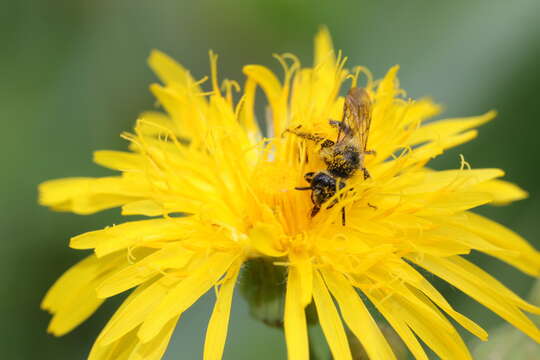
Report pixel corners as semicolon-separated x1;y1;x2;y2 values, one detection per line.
40;29;540;360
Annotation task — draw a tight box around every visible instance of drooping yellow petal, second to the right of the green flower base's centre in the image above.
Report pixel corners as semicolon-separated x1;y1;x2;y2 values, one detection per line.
313;272;352;360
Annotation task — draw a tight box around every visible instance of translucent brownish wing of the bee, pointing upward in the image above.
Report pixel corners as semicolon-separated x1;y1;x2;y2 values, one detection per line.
336;87;371;151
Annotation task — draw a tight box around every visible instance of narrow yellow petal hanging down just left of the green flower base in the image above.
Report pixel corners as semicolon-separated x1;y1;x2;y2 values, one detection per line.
204;259;242;360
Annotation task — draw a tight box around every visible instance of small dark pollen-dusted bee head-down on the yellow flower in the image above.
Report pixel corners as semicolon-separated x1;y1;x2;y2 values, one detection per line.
285;87;375;225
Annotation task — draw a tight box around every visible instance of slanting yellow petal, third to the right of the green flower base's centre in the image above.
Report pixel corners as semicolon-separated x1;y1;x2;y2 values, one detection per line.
323;271;396;360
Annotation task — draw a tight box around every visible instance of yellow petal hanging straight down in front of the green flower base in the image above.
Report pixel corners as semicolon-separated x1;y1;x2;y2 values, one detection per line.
284;267;309;360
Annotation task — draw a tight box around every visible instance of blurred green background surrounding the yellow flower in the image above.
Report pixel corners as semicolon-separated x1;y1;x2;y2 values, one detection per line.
0;0;540;360
